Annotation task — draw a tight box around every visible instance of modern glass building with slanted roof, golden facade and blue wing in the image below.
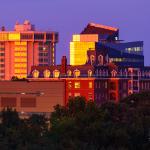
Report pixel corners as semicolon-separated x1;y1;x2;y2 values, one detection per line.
70;23;144;67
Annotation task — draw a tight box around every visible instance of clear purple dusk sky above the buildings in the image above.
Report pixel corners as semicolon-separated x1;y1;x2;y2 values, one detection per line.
0;0;150;65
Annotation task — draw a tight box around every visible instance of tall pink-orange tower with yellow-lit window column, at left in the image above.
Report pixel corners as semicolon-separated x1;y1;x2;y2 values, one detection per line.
0;20;58;80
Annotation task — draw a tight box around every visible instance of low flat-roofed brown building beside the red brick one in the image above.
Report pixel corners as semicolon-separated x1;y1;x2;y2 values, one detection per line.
0;79;65;115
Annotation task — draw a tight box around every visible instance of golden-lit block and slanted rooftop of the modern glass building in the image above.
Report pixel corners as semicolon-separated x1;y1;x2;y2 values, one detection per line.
70;23;119;65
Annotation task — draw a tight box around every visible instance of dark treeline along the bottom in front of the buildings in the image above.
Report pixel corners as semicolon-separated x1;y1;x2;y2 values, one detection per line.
0;92;150;150
